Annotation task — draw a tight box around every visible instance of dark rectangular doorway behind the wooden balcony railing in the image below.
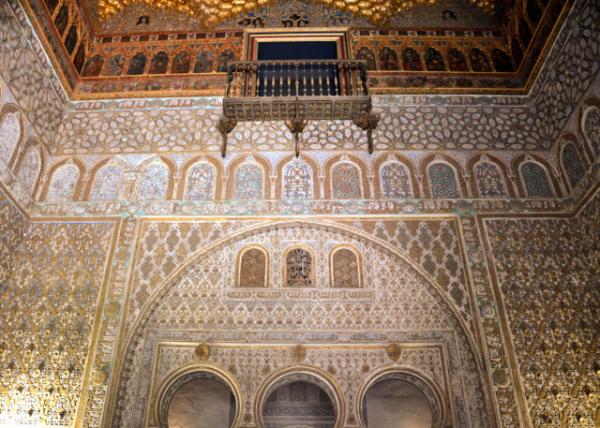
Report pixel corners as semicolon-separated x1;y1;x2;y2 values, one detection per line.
258;41;338;96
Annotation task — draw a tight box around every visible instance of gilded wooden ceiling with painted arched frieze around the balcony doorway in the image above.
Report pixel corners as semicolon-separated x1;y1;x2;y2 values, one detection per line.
24;0;572;99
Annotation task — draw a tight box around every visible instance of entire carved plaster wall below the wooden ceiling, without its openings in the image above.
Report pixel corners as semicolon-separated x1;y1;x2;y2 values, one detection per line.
0;0;600;428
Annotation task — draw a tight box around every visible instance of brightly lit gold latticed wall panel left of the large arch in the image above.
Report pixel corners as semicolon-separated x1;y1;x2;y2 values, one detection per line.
0;222;113;426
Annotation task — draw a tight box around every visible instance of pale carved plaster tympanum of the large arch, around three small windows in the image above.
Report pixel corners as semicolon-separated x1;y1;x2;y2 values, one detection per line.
117;221;492;428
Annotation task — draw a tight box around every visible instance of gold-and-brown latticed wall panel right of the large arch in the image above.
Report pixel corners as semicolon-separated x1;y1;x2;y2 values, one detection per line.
485;192;600;427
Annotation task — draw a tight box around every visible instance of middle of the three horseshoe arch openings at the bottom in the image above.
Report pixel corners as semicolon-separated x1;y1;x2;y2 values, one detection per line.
260;372;339;428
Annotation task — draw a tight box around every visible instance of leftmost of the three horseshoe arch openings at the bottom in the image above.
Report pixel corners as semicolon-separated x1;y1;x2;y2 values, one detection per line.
159;370;239;428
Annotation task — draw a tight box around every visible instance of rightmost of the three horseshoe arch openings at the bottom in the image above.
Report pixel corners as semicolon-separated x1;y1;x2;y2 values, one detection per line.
360;371;443;428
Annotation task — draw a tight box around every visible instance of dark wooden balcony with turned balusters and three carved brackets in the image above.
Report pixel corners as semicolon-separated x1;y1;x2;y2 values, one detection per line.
220;60;378;156
